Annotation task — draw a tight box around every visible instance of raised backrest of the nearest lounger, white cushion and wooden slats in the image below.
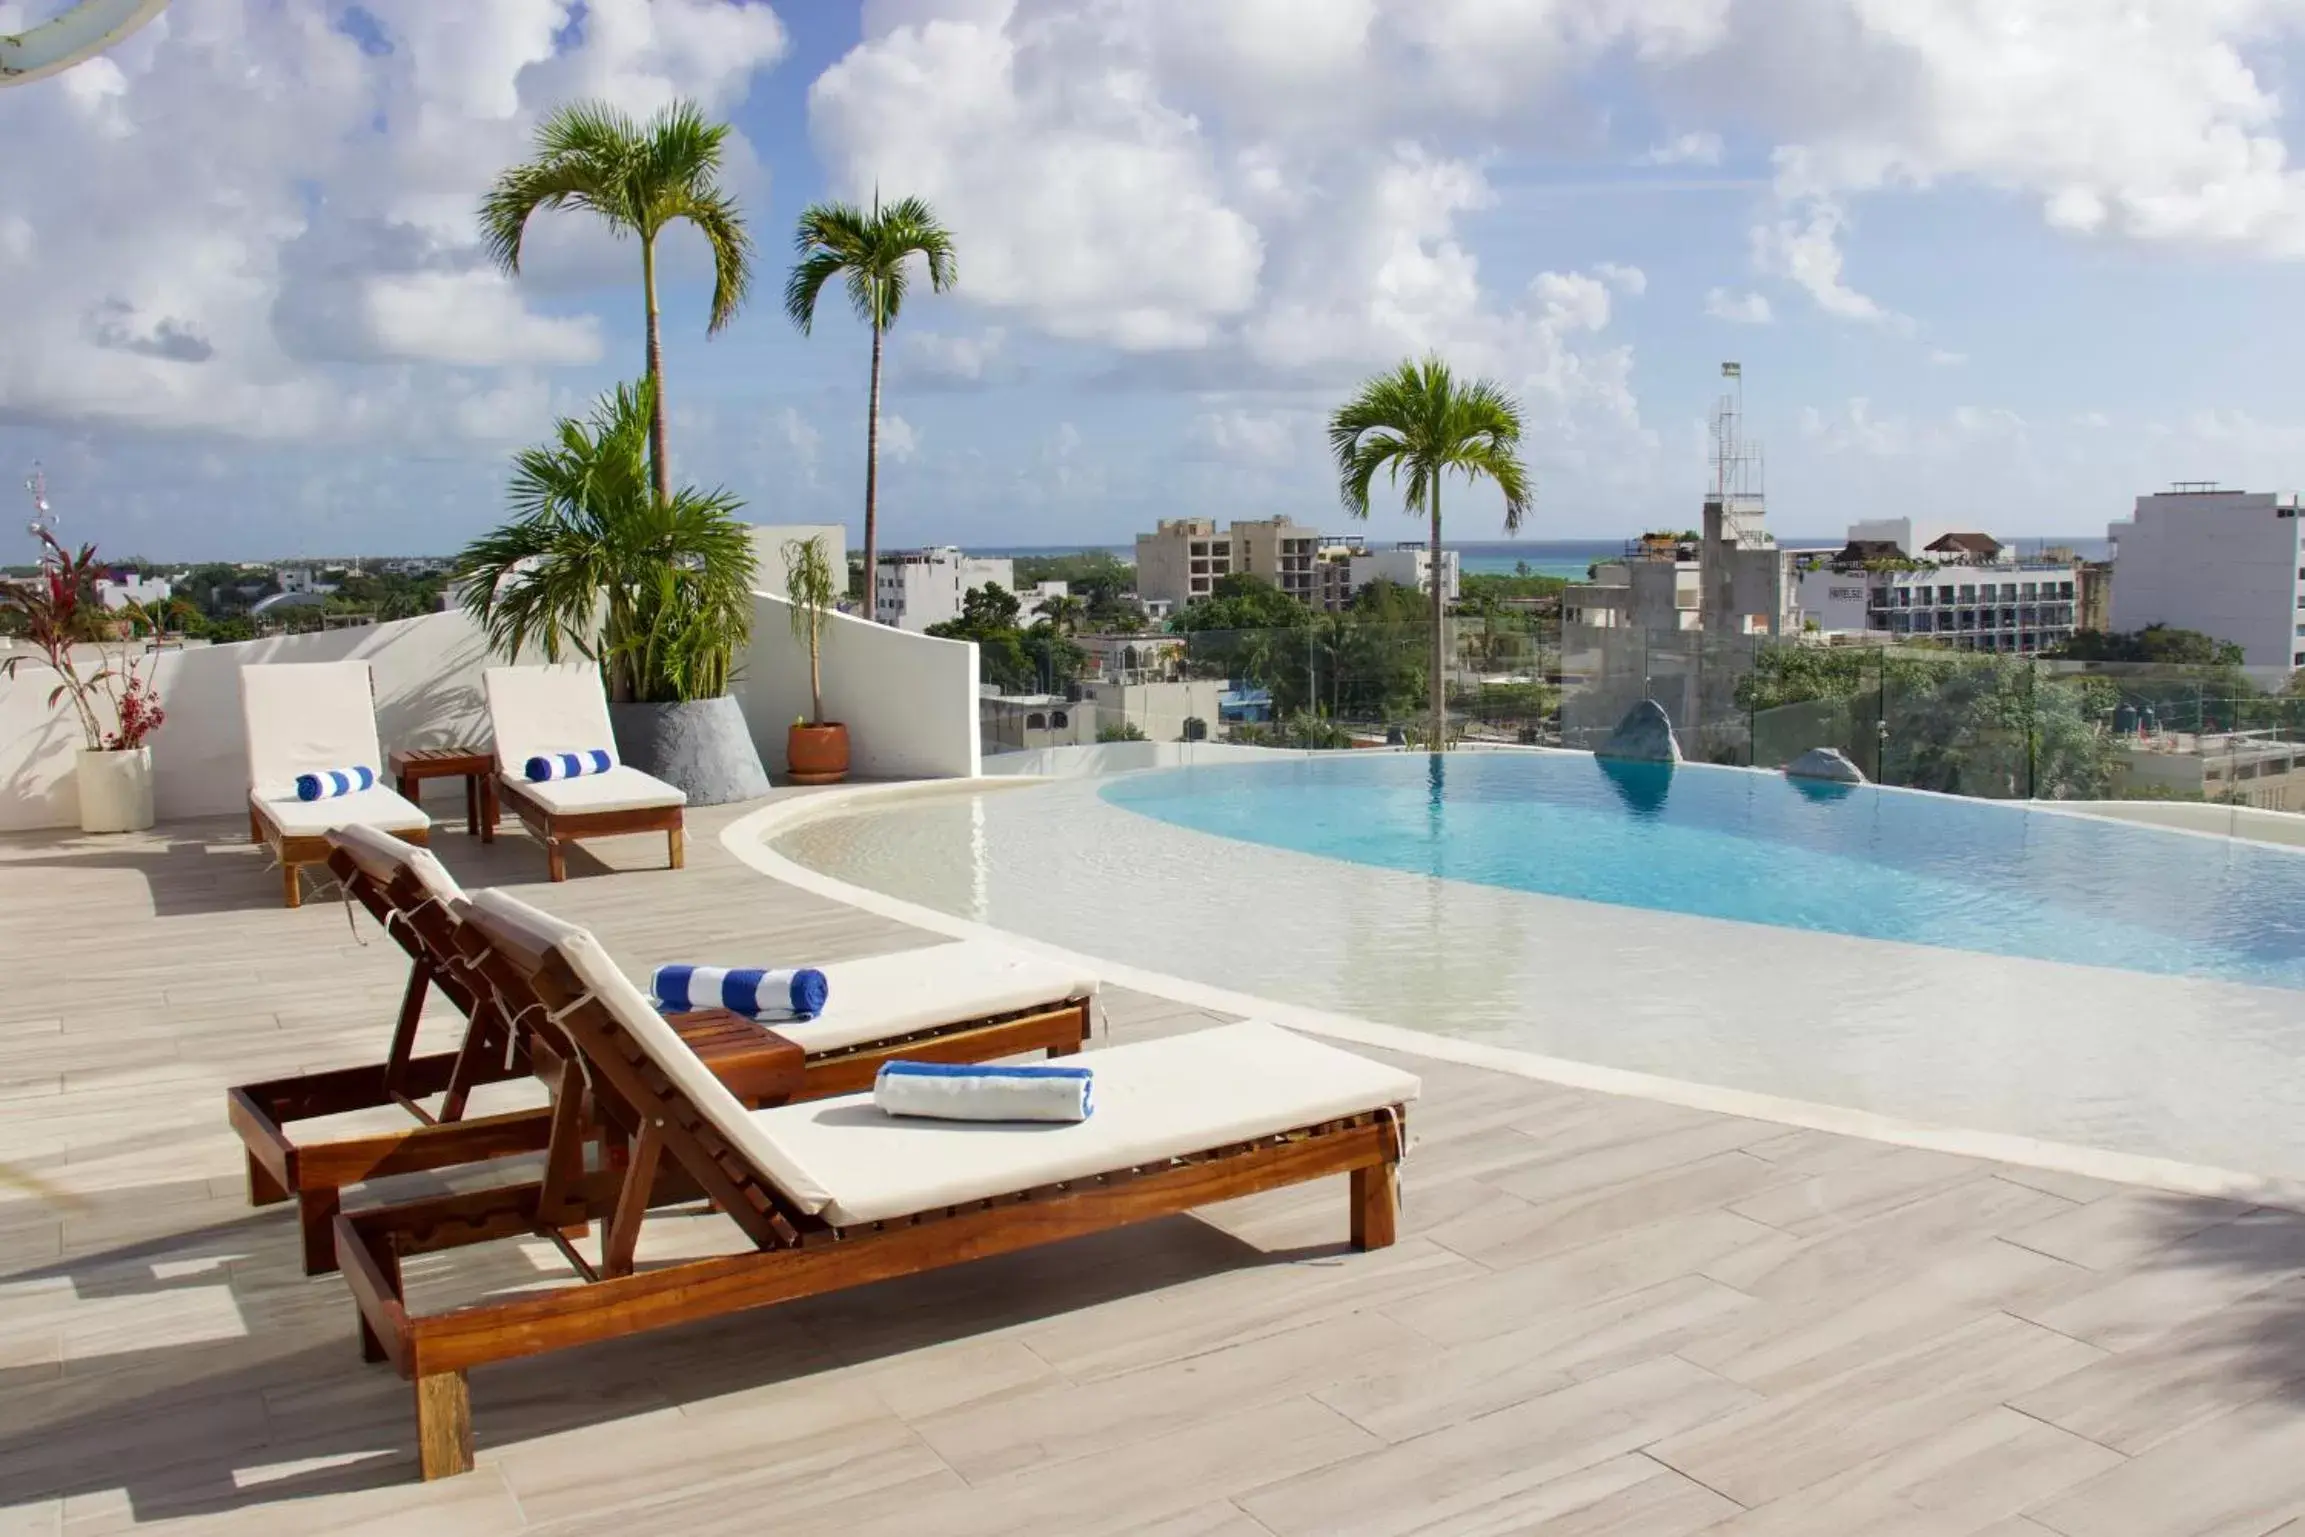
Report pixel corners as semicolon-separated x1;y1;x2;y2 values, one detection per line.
463;892;832;1237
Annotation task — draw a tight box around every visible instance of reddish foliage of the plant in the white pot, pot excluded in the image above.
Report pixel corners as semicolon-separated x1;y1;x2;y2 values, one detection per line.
0;528;166;751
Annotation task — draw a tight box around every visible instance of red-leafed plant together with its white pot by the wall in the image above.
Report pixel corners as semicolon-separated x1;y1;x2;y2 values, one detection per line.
0;523;166;832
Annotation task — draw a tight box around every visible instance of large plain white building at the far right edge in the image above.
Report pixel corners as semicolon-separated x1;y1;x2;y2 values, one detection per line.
2104;482;2305;668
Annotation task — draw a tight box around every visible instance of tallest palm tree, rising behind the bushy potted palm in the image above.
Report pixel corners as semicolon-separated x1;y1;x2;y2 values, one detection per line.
479;101;751;502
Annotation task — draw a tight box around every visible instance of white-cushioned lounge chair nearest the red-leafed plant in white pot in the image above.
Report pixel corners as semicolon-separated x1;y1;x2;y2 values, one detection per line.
240;661;431;908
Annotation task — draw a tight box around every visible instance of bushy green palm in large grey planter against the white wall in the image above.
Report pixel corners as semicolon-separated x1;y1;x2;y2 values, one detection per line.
454;380;768;807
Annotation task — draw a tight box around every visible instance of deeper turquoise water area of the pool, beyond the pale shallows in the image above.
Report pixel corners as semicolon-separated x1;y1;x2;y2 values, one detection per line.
1099;754;2305;989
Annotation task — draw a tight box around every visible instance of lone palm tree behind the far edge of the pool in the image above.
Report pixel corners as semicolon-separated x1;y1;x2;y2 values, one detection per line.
1328;355;1533;751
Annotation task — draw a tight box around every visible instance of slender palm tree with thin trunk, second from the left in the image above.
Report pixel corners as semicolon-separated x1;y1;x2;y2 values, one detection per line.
784;194;954;618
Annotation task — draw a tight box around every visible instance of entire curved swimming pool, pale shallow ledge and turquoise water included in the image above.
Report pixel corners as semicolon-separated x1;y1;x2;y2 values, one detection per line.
770;754;2305;1175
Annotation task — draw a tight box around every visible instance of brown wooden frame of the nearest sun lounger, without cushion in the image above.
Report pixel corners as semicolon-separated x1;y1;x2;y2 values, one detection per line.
334;908;1415;1479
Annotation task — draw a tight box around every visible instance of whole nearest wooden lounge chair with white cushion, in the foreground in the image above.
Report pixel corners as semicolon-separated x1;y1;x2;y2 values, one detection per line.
334;892;1418;1479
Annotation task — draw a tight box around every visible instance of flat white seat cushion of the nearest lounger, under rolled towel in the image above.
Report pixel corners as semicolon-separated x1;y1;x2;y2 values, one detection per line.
751;1021;1418;1226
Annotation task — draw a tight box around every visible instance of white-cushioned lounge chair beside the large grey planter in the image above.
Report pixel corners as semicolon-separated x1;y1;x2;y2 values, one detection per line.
482;661;689;880
